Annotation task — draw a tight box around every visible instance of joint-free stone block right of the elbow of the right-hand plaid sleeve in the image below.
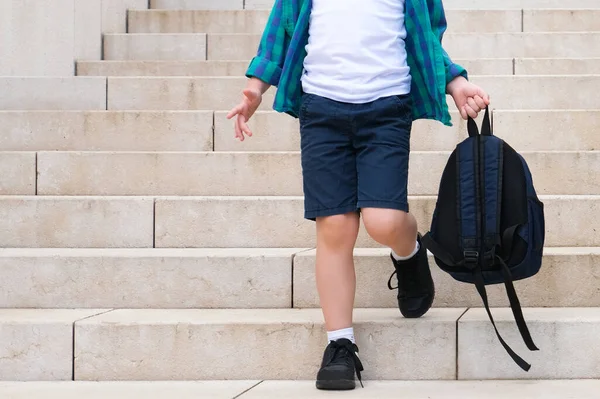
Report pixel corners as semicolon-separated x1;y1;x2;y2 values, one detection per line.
446;32;600;58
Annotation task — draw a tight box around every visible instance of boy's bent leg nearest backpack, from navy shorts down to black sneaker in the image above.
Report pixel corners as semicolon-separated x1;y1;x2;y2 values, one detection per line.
355;95;434;317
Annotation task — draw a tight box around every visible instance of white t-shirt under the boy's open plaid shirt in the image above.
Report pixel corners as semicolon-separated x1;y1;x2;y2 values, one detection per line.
302;0;411;103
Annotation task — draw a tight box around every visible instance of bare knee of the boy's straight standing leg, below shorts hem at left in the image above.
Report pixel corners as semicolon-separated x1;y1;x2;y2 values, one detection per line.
317;213;359;248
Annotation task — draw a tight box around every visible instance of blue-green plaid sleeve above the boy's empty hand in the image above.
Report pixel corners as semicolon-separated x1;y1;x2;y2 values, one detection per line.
246;0;289;86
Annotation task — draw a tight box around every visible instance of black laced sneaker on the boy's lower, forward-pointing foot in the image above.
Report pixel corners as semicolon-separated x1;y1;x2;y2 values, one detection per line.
317;338;363;391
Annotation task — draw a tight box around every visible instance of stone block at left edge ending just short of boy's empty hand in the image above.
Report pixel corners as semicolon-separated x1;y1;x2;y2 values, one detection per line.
0;111;213;151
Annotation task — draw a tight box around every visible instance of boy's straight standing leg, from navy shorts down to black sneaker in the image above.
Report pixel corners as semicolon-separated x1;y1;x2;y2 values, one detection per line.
300;95;362;390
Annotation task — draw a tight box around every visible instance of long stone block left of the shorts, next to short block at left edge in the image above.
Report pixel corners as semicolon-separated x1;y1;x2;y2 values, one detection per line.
38;152;302;195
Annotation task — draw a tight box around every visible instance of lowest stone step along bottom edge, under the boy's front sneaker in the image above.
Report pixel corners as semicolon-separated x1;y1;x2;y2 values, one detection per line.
0;382;600;399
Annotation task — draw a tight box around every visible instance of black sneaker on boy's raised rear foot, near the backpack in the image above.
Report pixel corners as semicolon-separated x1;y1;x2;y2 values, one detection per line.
388;234;435;318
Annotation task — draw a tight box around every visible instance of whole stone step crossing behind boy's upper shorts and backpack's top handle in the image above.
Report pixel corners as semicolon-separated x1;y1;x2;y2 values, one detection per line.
0;110;600;152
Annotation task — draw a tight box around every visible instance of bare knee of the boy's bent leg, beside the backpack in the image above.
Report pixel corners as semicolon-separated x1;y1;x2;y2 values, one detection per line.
362;208;417;246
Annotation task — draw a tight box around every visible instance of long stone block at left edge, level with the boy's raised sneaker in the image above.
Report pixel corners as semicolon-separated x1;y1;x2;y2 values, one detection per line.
0;248;303;309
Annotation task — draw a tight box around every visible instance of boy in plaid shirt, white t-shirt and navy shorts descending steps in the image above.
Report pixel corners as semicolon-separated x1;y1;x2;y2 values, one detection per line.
228;0;489;390
